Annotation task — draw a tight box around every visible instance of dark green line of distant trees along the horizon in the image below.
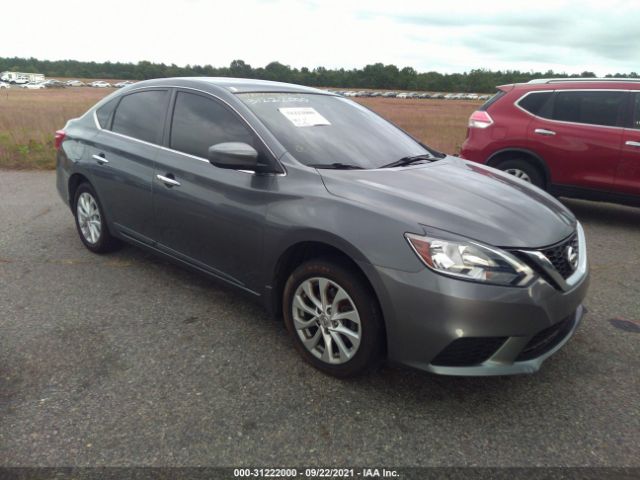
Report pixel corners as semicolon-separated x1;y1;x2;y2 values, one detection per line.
0;57;639;92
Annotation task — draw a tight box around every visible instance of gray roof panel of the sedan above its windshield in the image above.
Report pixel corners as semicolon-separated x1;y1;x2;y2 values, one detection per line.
128;77;333;95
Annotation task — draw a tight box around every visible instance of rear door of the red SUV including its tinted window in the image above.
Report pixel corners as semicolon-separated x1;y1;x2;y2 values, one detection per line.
529;90;628;191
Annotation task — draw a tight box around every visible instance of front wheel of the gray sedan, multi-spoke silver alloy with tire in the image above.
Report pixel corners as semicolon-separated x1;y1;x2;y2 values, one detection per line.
282;258;383;378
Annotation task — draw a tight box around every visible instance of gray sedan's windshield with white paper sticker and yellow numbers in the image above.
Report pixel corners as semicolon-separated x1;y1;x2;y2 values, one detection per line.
238;93;432;168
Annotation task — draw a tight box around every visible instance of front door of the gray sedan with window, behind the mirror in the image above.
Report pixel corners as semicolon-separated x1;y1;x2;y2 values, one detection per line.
153;91;276;289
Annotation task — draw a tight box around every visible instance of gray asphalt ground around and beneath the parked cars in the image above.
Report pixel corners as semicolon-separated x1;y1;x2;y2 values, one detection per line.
0;171;640;466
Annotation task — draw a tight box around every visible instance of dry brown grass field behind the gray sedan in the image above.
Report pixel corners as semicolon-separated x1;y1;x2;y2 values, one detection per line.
0;87;480;169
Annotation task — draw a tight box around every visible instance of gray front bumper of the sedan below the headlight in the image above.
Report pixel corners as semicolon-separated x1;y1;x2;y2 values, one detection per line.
376;258;589;376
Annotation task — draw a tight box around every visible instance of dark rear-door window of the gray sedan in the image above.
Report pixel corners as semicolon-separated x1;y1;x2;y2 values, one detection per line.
112;90;169;143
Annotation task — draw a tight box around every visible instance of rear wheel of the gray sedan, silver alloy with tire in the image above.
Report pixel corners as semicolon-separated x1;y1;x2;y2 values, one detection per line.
73;183;120;253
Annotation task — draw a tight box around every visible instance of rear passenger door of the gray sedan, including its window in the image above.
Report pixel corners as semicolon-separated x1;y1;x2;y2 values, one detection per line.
89;89;169;243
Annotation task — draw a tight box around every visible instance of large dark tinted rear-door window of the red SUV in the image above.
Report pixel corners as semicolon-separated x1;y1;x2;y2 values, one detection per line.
552;91;627;127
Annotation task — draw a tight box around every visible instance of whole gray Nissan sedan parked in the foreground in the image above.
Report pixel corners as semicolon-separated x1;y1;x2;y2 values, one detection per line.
56;78;588;377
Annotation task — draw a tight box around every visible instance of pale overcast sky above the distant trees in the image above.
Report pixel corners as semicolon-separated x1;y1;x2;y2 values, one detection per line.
5;0;640;75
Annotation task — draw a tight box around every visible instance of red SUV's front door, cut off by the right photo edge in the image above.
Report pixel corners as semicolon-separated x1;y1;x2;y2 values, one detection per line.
615;92;640;195
